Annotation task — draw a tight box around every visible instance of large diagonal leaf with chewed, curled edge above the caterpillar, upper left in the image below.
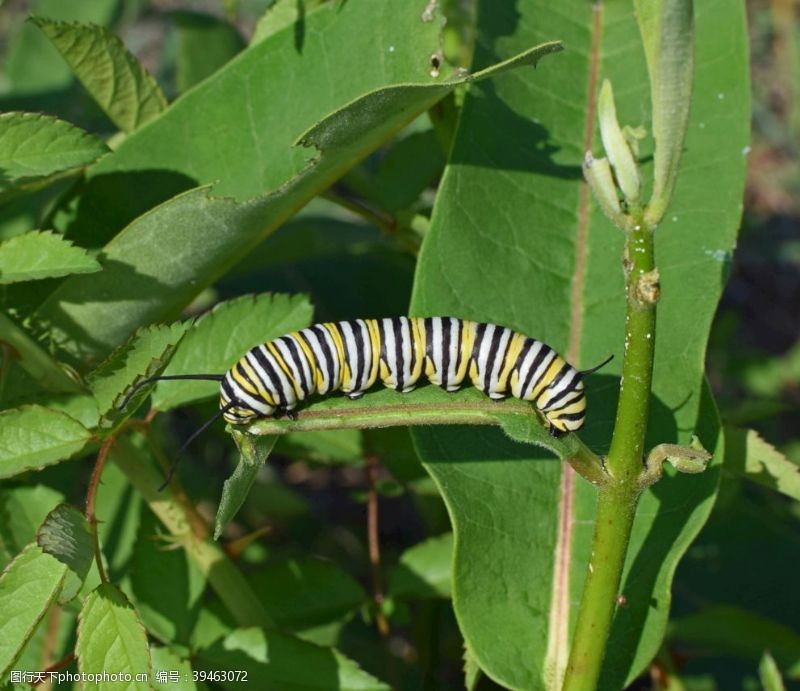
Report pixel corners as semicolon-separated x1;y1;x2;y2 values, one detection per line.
32;0;559;370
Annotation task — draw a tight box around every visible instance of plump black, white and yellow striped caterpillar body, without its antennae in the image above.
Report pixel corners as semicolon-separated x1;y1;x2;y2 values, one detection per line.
220;317;586;436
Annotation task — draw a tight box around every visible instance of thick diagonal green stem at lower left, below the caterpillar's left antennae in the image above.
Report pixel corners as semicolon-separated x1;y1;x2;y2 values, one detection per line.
111;437;274;628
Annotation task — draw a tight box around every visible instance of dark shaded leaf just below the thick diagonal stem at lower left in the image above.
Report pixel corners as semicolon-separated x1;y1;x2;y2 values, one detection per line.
130;506;206;645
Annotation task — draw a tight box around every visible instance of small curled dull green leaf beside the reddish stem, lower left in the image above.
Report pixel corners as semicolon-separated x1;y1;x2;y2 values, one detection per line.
36;504;94;604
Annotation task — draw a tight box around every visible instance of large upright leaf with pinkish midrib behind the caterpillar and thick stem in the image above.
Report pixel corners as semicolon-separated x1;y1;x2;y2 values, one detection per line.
412;0;749;689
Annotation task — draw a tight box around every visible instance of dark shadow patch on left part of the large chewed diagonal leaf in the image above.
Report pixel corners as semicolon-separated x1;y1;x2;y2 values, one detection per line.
62;170;199;249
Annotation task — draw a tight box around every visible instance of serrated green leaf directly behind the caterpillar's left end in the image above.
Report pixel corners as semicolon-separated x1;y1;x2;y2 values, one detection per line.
153;293;313;410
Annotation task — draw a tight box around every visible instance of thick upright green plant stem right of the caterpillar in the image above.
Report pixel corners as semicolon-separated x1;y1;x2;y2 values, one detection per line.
563;224;659;691
